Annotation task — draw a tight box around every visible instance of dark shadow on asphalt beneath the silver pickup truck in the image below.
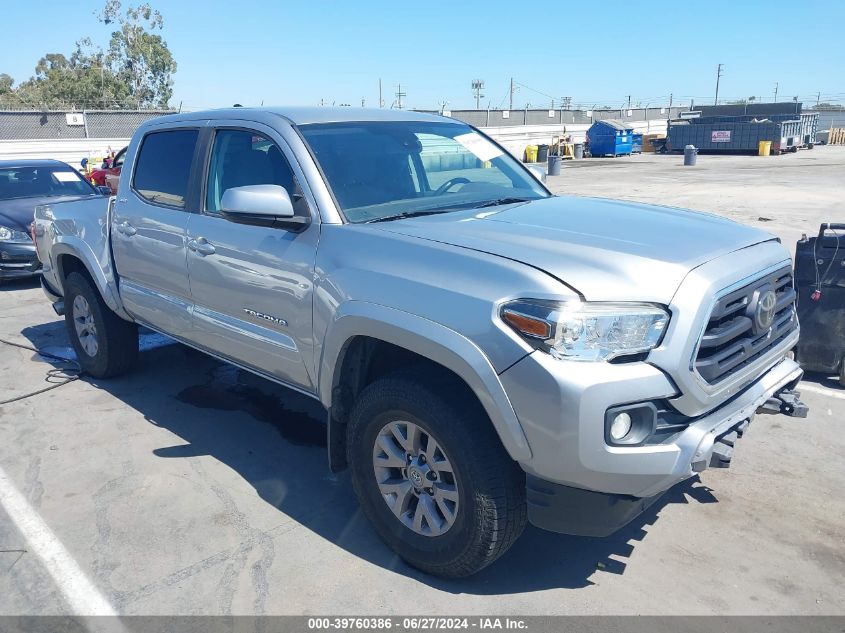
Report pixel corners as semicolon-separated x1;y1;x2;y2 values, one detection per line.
22;321;717;595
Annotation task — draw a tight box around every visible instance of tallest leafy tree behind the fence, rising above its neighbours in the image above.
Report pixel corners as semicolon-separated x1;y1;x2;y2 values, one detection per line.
98;0;176;107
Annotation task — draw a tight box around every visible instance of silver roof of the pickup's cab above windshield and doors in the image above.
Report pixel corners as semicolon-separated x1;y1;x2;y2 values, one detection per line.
141;106;460;125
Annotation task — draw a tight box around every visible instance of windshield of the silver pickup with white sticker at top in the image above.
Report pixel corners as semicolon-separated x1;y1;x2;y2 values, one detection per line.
300;121;549;222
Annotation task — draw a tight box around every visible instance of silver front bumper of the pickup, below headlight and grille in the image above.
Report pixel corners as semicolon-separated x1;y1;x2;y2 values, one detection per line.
500;352;803;536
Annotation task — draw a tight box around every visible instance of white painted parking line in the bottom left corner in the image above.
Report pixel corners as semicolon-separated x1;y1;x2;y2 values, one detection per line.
0;468;117;616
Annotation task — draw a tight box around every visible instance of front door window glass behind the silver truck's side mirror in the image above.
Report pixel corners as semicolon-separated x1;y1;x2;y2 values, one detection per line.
205;130;297;213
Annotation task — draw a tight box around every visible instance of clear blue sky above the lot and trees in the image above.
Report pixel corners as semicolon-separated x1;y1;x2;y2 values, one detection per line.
0;0;845;109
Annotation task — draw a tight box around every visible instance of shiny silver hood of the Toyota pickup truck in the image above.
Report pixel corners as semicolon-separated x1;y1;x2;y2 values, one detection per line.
375;196;775;304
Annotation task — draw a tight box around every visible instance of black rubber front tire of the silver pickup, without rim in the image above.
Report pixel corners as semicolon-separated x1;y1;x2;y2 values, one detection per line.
347;372;526;578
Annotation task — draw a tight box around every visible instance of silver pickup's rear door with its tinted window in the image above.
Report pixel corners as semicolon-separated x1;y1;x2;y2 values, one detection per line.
111;125;199;338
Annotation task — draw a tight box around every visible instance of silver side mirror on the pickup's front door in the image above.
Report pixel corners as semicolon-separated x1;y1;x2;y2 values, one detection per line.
220;185;311;229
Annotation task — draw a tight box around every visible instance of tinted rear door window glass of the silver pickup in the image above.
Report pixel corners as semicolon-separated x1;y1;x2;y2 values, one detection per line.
132;130;199;209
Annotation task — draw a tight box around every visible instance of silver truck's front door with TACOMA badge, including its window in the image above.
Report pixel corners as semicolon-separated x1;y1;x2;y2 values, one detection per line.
188;122;320;392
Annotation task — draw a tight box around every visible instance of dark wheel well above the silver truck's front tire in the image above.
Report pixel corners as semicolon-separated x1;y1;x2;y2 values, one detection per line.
329;336;484;472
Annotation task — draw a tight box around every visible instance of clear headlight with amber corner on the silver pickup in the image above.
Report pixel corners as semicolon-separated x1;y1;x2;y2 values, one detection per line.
501;300;669;361
